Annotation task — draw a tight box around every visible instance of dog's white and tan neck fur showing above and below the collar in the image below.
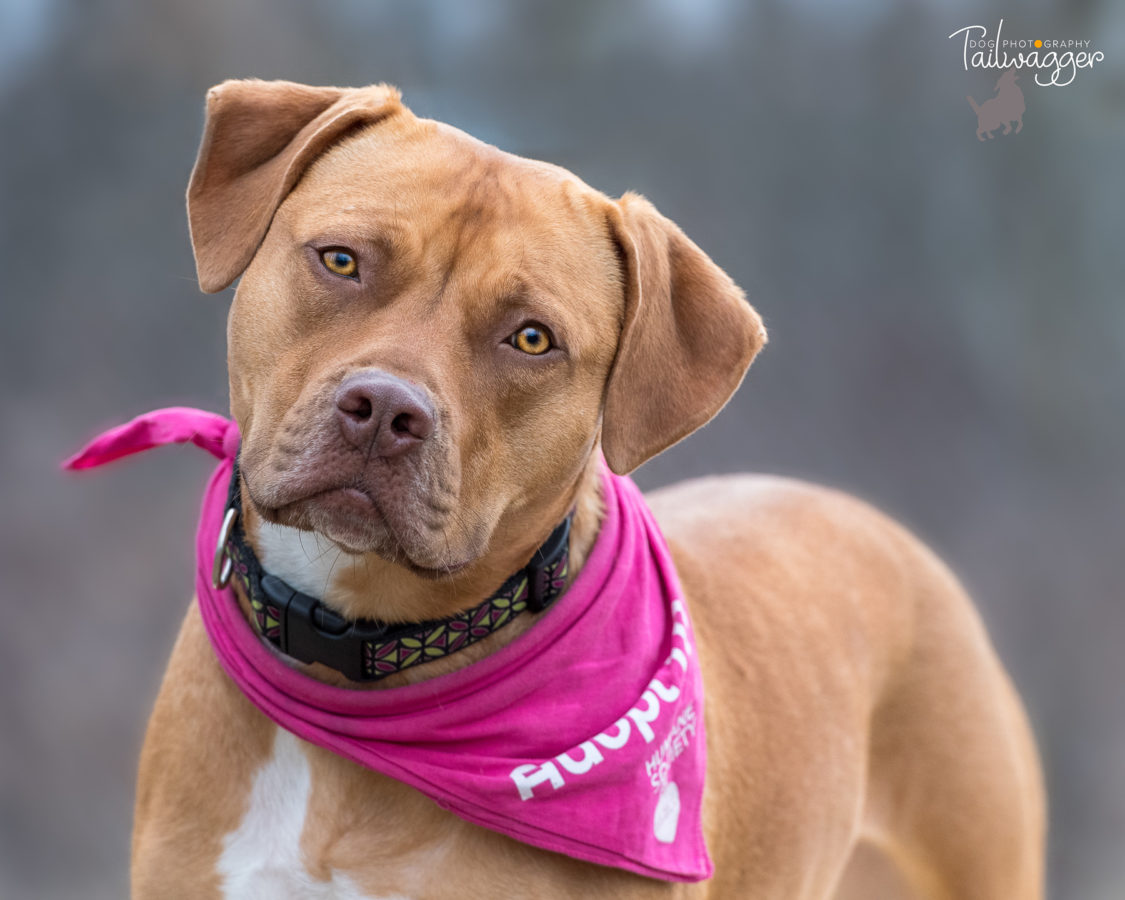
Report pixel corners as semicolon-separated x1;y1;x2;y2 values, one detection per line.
237;451;604;689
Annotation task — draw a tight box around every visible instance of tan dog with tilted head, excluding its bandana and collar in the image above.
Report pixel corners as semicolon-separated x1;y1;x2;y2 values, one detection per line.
133;81;1044;900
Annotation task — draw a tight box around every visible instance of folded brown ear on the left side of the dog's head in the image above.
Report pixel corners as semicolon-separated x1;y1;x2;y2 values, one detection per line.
188;80;403;294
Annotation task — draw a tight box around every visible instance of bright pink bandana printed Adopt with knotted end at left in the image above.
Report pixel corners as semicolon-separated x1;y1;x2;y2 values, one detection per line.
64;408;712;881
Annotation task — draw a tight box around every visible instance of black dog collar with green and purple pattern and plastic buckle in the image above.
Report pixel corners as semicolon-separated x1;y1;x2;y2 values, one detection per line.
212;461;573;682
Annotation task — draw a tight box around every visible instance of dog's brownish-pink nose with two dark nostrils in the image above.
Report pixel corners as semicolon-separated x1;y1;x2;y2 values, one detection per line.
336;369;434;459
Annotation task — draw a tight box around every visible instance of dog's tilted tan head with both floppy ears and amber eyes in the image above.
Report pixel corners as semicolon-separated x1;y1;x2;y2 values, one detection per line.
188;81;765;612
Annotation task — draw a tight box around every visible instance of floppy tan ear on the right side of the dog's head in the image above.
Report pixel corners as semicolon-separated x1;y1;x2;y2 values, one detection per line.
602;194;766;475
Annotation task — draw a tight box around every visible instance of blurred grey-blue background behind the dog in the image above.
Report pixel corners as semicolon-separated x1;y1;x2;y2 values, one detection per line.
0;0;1125;900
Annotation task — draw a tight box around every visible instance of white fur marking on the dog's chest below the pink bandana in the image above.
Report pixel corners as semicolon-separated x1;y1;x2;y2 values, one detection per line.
216;728;407;900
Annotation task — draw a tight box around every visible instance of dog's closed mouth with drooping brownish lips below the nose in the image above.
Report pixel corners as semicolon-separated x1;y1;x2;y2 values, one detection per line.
246;483;474;579
